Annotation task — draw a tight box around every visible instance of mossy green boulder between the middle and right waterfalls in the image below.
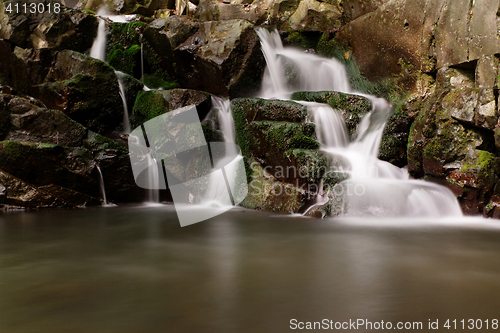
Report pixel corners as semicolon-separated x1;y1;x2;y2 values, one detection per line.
231;98;328;188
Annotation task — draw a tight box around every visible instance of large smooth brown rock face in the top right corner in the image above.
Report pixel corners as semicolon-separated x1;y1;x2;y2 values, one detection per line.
340;0;499;89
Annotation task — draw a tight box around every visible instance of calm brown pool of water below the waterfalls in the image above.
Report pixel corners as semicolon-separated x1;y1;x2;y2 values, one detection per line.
0;207;500;333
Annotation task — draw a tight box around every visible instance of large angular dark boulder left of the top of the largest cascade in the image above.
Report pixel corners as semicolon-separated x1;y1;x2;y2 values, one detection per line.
174;20;265;97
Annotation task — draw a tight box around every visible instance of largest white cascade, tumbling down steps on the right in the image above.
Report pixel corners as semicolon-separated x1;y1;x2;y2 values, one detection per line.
257;28;462;217
